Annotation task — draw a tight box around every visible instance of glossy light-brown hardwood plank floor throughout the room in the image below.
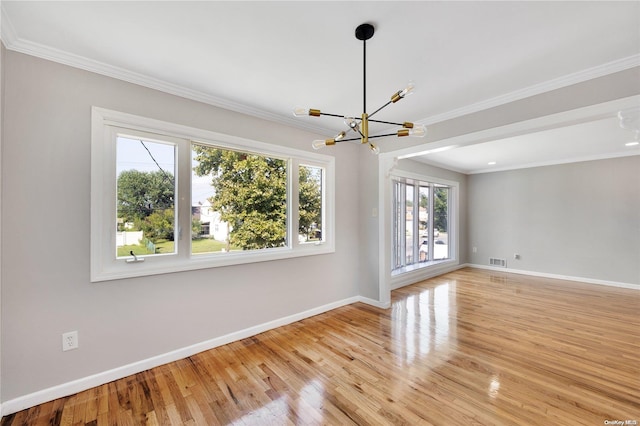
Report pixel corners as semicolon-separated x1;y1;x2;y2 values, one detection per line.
2;269;640;426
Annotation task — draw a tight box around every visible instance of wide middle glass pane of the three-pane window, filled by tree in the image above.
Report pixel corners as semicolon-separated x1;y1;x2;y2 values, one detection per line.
191;144;287;254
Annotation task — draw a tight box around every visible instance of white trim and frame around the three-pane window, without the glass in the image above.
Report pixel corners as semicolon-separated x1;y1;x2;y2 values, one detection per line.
91;107;335;282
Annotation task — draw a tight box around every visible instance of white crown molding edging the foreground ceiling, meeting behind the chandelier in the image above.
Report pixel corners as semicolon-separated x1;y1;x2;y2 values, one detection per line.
0;5;640;134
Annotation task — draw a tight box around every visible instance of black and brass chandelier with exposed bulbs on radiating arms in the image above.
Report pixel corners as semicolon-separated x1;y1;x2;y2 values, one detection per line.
293;24;427;154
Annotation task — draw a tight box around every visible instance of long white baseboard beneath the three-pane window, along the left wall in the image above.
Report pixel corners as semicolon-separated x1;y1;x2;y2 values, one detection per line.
0;296;370;416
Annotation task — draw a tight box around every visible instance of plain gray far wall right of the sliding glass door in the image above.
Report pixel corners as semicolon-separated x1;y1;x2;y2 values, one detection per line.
468;155;640;284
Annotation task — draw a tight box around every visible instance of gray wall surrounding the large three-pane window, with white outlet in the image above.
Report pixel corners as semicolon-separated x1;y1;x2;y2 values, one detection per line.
1;51;359;401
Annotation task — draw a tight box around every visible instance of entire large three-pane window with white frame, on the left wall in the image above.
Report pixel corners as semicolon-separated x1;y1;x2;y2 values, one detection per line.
95;107;338;282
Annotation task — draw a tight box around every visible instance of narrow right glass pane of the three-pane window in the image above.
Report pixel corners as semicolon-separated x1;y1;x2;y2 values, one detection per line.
298;166;323;243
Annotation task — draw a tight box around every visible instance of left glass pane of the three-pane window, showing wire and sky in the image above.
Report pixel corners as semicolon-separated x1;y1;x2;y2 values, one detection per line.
116;136;176;257
